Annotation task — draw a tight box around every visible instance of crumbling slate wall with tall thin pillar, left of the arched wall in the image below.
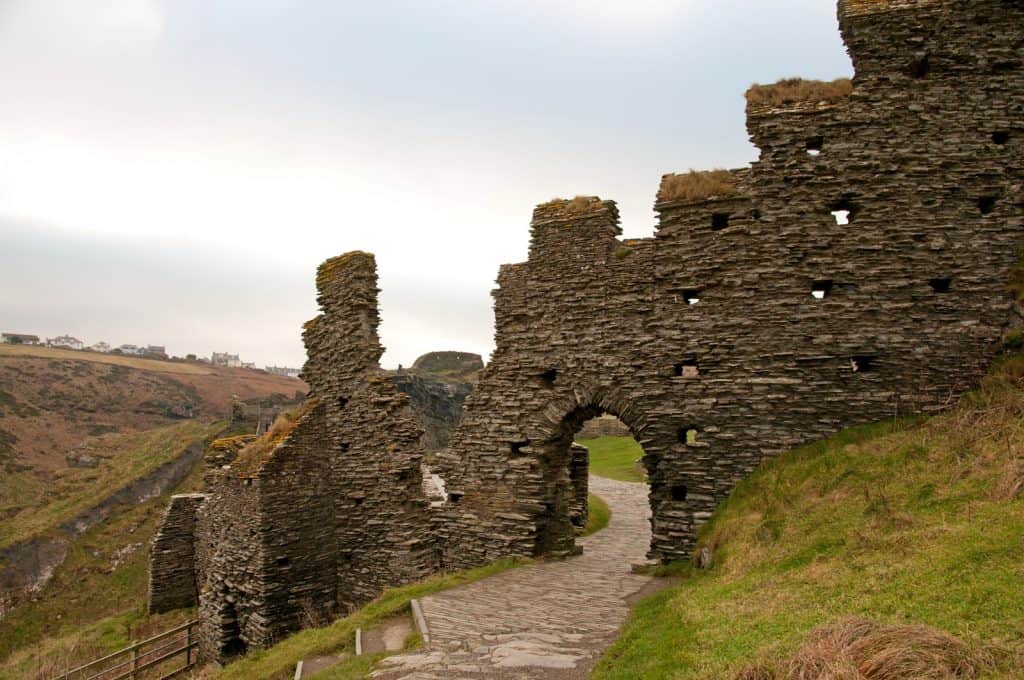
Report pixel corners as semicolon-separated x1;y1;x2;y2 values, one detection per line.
182;253;438;660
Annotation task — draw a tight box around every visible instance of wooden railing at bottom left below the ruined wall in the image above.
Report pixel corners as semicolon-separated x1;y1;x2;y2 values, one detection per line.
53;621;199;680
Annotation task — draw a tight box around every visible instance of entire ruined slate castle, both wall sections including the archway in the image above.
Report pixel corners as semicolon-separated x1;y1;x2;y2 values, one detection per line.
151;0;1024;658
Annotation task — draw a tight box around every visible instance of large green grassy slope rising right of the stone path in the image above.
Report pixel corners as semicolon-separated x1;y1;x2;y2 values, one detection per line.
594;359;1024;678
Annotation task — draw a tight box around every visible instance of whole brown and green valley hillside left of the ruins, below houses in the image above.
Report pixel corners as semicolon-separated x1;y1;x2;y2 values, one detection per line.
0;345;306;678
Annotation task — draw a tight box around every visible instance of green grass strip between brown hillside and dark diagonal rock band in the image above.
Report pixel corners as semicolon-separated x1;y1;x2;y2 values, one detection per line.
0;421;224;548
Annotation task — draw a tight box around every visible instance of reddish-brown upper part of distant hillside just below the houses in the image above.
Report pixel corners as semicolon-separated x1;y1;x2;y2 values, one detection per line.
0;345;307;475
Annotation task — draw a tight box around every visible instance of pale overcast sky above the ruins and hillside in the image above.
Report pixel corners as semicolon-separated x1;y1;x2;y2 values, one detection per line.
0;0;851;366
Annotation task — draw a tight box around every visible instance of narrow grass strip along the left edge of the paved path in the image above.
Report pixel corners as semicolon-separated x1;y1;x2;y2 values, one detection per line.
211;559;522;680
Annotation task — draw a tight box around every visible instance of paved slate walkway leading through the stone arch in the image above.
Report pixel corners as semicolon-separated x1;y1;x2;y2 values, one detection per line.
373;477;651;680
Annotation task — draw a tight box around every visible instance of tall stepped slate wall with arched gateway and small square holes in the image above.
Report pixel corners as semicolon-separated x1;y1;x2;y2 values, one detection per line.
439;0;1024;566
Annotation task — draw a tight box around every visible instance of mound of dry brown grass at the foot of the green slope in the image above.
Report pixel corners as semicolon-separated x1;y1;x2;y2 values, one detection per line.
736;618;992;680
